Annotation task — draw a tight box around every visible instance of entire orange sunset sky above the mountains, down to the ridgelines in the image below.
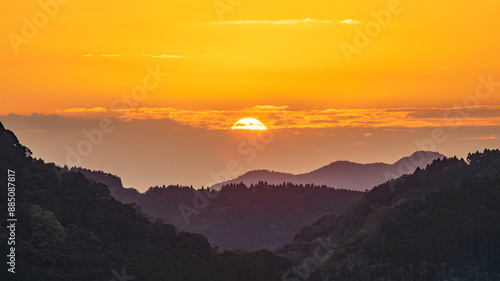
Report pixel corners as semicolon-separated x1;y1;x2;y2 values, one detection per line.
0;0;500;190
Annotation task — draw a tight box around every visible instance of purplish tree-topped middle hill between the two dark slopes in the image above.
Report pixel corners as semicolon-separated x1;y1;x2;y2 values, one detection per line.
71;165;362;250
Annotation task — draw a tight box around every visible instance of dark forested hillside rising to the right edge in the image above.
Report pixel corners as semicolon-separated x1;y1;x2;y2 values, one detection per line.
277;150;500;281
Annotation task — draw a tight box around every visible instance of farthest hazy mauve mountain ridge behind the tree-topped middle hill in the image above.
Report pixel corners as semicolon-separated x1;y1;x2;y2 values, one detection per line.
211;151;445;191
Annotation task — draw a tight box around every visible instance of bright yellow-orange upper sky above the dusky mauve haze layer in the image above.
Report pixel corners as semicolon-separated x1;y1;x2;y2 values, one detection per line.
0;0;500;116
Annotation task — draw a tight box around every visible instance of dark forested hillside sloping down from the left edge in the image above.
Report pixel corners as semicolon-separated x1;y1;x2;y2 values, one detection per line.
0;123;290;281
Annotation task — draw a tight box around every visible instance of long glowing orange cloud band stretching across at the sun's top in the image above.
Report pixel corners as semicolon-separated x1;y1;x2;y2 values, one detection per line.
58;105;500;130
